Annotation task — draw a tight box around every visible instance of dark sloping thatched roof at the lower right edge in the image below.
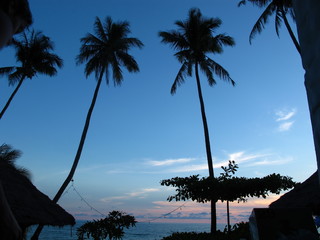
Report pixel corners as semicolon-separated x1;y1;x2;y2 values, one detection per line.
269;172;320;215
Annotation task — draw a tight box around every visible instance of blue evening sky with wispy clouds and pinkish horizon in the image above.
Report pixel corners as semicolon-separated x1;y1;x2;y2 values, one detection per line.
0;0;316;223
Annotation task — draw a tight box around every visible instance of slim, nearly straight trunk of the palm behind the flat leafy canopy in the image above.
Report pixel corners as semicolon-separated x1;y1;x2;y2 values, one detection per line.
195;63;217;233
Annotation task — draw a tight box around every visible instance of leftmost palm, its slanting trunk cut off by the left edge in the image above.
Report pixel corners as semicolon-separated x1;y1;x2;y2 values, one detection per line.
0;30;63;119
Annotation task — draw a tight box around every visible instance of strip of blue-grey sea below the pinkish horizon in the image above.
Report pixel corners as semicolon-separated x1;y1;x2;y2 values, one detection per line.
27;221;225;240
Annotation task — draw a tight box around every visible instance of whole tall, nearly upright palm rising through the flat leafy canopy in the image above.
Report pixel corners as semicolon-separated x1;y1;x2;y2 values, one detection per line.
159;8;235;232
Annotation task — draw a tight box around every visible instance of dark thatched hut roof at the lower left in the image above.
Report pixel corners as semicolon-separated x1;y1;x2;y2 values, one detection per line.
0;145;75;228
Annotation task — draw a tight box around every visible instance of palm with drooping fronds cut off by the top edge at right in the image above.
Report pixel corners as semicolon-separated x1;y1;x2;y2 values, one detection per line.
238;0;301;54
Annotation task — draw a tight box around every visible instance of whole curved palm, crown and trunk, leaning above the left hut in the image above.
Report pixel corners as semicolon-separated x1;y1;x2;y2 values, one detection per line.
32;17;143;239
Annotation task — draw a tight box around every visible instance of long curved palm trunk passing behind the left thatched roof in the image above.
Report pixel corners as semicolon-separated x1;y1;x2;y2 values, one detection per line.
31;73;103;240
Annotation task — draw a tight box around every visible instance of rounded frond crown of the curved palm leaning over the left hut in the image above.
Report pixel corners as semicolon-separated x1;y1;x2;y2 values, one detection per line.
76;17;143;85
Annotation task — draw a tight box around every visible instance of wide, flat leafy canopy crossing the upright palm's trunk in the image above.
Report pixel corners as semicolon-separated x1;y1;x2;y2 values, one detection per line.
160;170;295;203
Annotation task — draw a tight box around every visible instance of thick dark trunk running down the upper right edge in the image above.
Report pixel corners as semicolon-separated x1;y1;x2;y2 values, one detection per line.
293;0;320;180
